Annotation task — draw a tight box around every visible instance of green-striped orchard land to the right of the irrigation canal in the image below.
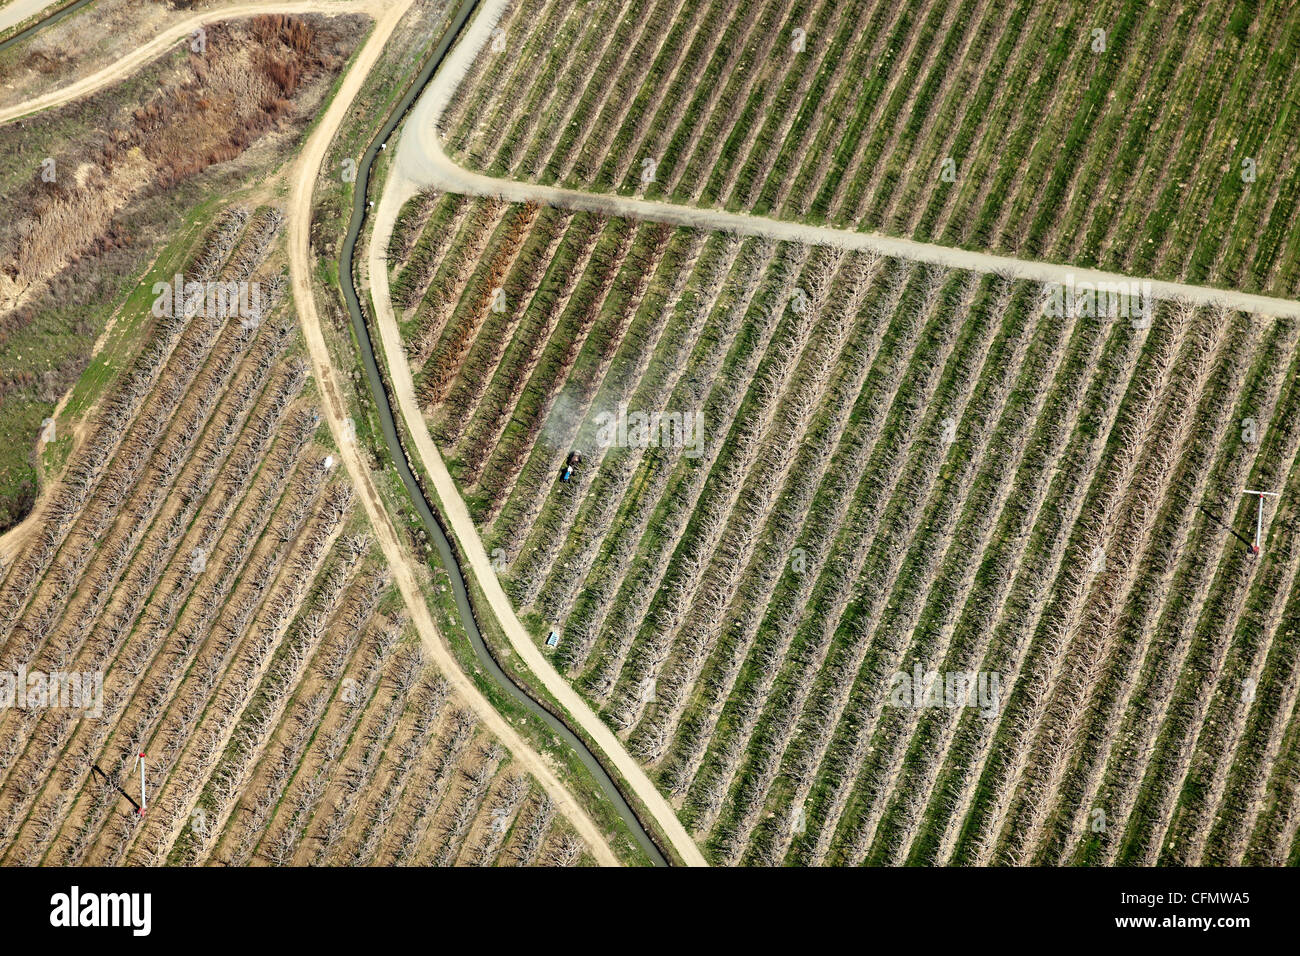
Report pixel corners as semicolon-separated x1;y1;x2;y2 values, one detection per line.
387;3;1297;865
